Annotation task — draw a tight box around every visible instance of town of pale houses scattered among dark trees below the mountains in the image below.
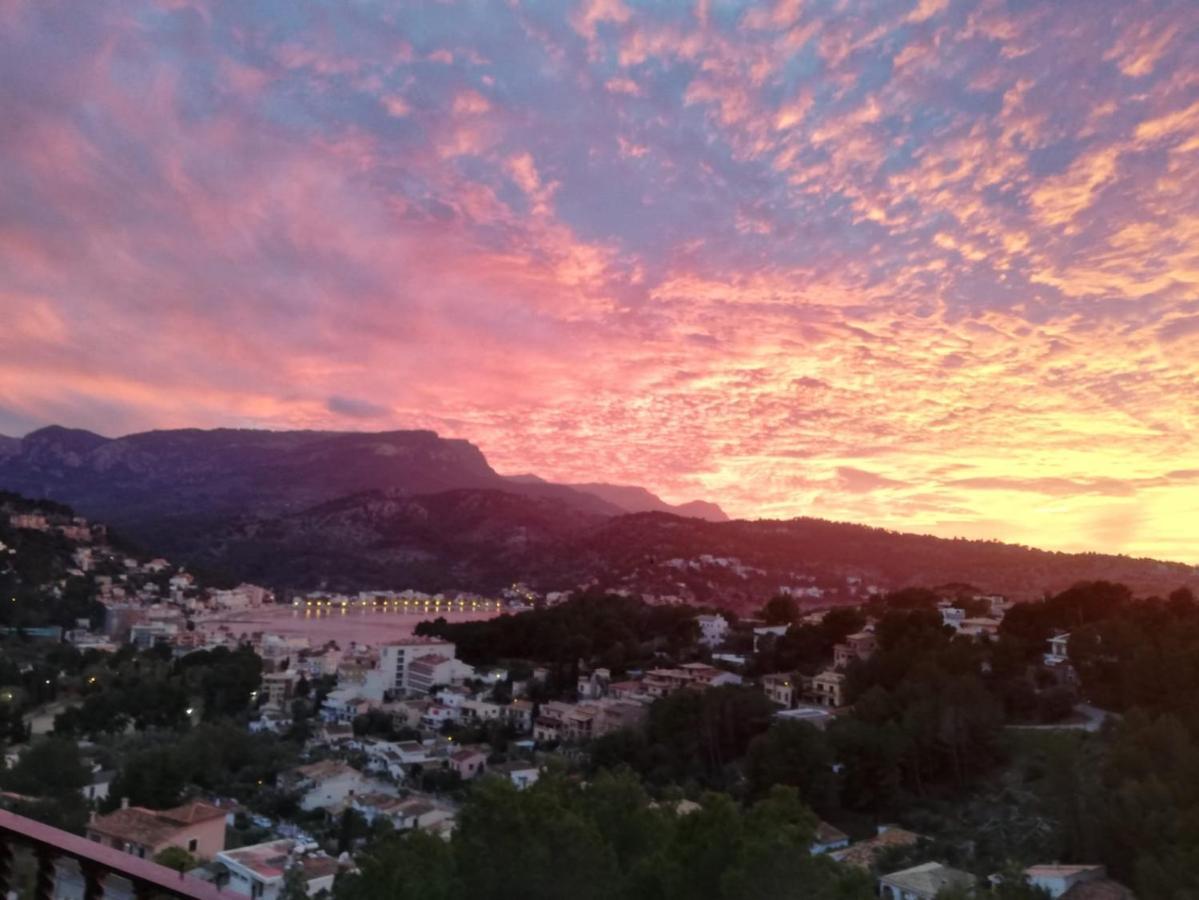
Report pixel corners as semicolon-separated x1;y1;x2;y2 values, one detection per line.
0;496;1179;900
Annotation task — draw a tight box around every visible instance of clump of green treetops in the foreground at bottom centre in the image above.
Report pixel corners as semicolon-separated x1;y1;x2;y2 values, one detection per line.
337;772;872;900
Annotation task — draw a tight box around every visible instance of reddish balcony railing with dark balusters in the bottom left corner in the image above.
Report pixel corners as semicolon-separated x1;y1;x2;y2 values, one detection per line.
0;810;226;900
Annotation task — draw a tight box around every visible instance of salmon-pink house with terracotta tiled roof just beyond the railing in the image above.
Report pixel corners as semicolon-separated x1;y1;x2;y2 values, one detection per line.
86;801;225;859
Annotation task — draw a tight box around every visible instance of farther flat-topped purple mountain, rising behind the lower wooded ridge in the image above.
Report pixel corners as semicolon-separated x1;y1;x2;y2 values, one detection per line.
0;425;700;558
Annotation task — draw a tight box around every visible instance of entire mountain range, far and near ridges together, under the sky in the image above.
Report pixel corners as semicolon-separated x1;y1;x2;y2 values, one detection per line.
0;427;1199;610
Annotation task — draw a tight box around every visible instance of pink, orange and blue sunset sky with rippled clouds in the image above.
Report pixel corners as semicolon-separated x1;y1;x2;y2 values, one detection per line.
0;0;1199;563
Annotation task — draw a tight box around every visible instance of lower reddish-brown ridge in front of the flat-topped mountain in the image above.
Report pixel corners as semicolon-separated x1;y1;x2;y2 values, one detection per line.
177;489;1199;611
